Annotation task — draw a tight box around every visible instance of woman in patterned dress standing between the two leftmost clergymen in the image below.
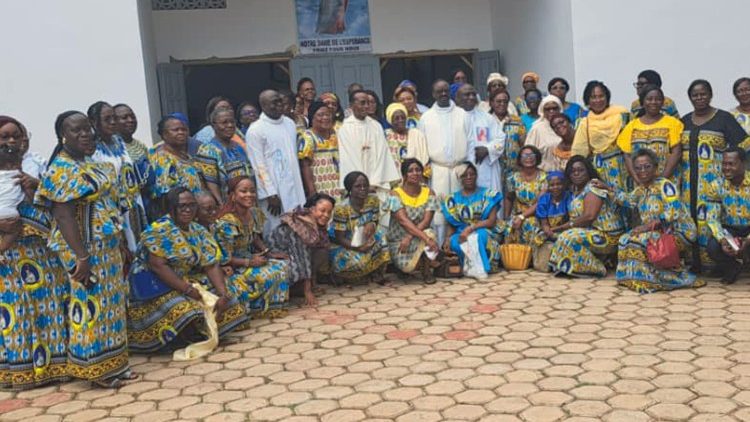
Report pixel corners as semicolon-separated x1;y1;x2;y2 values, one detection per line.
297;101;340;197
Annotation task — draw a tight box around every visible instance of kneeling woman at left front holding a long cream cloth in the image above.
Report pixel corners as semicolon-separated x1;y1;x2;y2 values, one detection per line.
127;186;250;353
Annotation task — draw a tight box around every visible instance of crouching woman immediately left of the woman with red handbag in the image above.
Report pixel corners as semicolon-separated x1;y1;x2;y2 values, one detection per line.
549;155;625;277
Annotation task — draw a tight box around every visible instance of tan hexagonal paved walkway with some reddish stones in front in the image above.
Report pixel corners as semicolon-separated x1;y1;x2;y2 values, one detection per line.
0;273;750;422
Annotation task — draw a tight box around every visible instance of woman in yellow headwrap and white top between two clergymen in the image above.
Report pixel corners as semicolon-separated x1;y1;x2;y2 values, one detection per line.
385;103;430;181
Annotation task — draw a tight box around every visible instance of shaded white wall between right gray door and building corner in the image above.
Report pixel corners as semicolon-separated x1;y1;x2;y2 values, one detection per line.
490;0;576;100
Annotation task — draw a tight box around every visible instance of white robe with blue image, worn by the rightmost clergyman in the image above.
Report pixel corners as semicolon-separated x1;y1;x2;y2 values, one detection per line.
466;107;505;192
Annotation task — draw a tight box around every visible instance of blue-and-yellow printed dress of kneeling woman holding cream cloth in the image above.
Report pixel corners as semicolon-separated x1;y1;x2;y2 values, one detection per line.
128;215;249;353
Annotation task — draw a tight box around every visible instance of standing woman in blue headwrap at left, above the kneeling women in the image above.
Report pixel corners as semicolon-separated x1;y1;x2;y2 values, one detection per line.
147;116;205;220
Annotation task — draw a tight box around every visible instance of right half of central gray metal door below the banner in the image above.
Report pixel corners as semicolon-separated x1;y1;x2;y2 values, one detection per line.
333;54;382;107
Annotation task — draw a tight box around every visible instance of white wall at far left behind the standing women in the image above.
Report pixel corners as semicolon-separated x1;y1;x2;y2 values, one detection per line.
0;0;157;156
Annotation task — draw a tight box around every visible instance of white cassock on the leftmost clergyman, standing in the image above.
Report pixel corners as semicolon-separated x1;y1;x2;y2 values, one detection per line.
245;113;305;235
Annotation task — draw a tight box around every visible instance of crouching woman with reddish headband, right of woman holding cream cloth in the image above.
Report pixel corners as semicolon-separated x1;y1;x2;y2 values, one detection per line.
214;176;289;318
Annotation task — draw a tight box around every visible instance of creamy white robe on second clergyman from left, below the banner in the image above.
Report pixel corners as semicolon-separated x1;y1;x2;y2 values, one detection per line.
337;116;401;189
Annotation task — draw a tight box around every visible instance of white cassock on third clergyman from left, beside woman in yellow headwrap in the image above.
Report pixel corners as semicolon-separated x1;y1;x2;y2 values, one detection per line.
418;101;469;243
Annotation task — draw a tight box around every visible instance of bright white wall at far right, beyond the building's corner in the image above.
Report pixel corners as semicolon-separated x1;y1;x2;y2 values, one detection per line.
572;0;750;114
